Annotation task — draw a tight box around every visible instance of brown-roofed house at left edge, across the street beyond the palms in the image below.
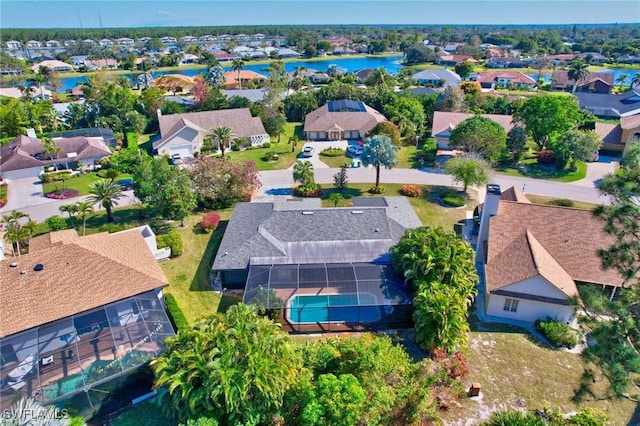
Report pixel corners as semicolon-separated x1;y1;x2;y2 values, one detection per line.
0;135;111;180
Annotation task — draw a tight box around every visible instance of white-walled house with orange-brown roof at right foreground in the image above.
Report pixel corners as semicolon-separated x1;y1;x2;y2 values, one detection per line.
476;185;624;324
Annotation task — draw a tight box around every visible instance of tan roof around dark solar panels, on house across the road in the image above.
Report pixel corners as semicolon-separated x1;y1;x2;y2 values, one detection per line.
304;103;386;135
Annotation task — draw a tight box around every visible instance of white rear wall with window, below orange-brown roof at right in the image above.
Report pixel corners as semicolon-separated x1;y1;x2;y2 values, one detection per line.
487;294;574;323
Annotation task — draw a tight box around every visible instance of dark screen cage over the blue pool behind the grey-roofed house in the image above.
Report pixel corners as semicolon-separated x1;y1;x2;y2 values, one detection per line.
243;263;412;332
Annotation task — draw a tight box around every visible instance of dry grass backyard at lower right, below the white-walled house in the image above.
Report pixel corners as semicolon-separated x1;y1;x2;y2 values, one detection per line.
442;320;635;425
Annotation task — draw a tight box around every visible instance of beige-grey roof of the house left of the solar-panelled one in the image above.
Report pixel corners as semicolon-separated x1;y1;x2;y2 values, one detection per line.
153;108;267;149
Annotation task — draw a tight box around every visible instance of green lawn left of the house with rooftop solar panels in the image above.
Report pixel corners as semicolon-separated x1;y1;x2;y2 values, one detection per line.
225;123;304;171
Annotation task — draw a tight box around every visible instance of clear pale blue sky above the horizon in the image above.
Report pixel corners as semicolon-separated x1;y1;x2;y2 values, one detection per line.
0;0;640;28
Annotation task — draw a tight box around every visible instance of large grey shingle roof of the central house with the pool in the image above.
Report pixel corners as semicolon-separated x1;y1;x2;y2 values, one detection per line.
213;197;421;270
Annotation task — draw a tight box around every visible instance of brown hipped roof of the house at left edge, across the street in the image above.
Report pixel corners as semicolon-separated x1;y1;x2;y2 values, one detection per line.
0;135;111;172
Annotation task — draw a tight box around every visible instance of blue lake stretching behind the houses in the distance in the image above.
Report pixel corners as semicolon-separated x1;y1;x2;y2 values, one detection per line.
58;55;402;92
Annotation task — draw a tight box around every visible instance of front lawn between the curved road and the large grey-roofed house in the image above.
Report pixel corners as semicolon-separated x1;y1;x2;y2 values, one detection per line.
322;183;478;229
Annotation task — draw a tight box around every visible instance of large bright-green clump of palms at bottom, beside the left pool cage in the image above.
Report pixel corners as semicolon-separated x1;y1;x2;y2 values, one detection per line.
152;304;301;425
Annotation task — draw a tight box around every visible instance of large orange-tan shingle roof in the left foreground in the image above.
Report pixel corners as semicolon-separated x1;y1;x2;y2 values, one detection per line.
0;232;167;337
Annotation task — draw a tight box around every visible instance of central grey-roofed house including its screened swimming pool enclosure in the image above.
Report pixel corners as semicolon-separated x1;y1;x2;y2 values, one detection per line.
212;197;421;332
